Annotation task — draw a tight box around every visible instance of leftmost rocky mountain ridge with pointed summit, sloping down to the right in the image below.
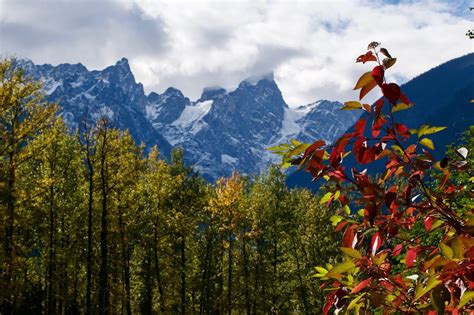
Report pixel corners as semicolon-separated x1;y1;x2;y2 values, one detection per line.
19;58;171;155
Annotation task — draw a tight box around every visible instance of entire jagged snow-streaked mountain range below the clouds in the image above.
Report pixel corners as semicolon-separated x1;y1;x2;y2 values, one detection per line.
19;58;357;180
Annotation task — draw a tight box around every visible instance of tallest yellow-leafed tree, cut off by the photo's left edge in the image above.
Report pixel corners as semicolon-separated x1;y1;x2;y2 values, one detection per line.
0;60;56;314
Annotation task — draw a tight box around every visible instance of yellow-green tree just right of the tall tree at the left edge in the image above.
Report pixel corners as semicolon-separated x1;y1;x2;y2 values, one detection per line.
19;118;82;314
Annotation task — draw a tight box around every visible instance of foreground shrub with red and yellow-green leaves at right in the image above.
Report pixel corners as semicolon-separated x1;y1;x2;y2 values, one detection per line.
273;42;474;314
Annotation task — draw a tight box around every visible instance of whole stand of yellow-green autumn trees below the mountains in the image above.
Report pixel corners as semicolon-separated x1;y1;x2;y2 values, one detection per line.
0;60;338;314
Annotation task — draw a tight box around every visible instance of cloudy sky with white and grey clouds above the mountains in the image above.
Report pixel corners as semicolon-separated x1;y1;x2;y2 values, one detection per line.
0;0;474;105
